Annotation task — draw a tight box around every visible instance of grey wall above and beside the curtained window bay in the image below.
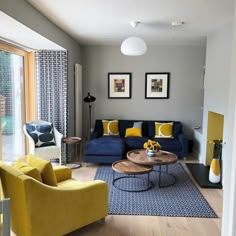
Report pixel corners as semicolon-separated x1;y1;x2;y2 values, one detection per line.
0;0;80;135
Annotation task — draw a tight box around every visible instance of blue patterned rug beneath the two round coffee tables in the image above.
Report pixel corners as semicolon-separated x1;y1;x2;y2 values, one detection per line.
94;163;217;218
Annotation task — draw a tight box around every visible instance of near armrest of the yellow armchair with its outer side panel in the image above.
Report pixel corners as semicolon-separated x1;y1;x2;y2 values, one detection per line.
24;178;108;235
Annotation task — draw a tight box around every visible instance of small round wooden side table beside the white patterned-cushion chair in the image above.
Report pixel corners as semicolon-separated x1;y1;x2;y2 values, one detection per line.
62;137;82;169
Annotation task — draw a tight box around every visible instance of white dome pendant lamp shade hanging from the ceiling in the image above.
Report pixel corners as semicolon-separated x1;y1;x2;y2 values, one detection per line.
120;37;147;56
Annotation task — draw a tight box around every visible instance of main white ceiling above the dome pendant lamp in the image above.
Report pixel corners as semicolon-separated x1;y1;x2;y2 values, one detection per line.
28;0;234;45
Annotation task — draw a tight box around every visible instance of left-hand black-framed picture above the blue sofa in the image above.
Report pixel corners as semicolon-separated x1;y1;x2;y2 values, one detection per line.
108;73;131;98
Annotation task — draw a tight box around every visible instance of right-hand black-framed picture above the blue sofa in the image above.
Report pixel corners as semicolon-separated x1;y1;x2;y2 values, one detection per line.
145;72;170;99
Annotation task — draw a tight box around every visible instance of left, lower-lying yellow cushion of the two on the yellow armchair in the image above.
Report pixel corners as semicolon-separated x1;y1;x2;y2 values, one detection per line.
12;160;42;182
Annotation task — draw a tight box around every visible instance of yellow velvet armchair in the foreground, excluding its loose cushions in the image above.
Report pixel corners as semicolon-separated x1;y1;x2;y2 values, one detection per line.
0;162;108;236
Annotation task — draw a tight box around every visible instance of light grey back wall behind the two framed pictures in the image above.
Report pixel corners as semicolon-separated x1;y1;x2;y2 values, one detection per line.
82;45;206;135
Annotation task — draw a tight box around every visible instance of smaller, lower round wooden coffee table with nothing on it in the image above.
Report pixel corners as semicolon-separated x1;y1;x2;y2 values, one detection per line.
112;160;152;192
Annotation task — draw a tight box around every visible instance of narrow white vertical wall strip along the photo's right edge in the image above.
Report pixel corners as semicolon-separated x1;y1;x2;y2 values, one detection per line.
221;1;236;236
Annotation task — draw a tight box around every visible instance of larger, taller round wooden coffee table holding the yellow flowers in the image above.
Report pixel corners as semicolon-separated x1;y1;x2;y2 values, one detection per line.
127;149;178;188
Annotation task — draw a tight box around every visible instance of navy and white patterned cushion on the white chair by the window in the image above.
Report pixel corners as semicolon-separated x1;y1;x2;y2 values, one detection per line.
26;123;56;147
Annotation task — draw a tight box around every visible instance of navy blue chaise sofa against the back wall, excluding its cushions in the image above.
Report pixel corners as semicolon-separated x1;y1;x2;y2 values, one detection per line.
83;120;188;163
